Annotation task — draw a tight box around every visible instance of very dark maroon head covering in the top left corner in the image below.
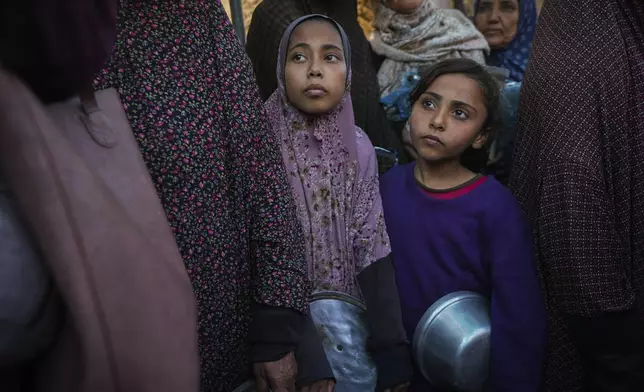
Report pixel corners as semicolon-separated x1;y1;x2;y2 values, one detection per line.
0;0;117;102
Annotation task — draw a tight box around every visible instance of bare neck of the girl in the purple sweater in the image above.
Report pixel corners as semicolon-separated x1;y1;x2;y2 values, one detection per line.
414;159;476;190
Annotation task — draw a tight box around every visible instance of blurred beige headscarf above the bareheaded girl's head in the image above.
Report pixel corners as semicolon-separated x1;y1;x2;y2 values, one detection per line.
370;0;490;97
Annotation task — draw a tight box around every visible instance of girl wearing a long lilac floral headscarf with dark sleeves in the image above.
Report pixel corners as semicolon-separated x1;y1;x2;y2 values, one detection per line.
266;15;411;391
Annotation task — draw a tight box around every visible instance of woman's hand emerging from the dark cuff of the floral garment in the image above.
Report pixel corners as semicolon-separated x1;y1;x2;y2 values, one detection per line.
253;353;297;392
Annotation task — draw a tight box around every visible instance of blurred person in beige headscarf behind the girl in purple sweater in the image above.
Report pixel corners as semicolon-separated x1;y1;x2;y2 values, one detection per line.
370;0;489;129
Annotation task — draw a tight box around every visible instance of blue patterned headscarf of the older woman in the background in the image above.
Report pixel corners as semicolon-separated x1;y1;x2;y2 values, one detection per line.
474;0;537;82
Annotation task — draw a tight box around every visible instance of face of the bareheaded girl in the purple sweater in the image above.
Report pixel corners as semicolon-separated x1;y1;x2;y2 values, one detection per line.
409;74;487;163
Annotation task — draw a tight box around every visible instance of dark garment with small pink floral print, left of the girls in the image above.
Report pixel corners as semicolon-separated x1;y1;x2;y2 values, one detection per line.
96;0;309;391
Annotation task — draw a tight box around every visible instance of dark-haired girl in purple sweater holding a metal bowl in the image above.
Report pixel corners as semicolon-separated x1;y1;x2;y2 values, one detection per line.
381;59;546;392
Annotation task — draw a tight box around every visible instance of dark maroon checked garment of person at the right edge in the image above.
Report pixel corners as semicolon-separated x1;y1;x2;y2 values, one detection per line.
510;0;644;392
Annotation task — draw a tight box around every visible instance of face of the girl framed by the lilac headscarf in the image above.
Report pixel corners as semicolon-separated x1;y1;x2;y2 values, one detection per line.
284;20;347;115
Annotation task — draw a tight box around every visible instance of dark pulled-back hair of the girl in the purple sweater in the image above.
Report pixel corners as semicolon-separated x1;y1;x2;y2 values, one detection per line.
409;59;502;173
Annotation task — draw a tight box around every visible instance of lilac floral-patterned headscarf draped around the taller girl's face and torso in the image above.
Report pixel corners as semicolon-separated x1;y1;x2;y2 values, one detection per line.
266;14;390;295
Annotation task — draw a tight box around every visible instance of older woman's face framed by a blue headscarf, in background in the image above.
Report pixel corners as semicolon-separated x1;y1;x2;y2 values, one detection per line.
474;0;519;49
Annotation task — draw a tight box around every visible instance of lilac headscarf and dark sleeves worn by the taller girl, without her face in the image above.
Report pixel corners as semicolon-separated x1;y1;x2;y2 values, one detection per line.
266;15;412;391
